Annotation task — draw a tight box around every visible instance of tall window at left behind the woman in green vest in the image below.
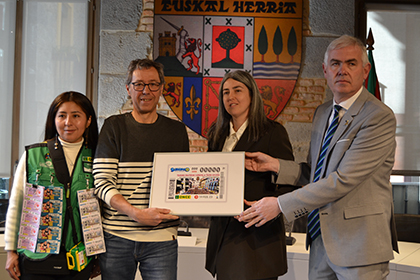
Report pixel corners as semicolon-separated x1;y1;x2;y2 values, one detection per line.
0;0;99;221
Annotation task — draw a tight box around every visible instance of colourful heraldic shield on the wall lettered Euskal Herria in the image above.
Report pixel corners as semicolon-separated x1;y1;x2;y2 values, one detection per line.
153;0;302;137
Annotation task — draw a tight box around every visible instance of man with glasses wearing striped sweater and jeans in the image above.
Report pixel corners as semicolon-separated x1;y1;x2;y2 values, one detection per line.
93;59;189;280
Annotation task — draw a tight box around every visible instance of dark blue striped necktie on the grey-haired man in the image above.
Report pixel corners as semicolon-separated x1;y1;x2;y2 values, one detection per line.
308;105;341;241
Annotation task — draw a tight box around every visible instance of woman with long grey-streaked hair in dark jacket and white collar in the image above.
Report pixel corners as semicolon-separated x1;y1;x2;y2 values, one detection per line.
206;71;294;280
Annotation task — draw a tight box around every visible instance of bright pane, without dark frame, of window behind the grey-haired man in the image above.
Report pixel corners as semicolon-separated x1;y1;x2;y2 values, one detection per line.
367;6;420;173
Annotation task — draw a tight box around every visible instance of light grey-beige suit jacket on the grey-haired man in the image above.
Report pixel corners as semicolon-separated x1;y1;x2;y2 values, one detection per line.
277;89;398;267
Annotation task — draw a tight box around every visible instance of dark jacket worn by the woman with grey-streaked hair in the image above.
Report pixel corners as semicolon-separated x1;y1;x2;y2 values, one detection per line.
206;121;294;279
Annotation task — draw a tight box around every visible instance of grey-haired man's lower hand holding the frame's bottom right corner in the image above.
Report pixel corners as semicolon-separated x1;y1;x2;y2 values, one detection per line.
236;197;281;228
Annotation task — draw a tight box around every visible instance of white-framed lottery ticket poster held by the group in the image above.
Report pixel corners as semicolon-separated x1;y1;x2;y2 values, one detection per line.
149;152;245;216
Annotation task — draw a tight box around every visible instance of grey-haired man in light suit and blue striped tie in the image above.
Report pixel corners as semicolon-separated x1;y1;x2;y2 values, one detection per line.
238;35;398;280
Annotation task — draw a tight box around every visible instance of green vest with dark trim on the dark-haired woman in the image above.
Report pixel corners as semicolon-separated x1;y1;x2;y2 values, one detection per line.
18;142;93;259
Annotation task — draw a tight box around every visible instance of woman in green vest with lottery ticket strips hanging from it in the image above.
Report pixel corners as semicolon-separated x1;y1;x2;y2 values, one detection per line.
5;91;98;280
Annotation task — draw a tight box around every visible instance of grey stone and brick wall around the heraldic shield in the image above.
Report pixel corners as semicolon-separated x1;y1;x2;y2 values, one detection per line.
98;0;354;226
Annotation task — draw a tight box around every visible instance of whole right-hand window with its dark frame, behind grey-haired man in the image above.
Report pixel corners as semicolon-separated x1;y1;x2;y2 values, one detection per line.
356;0;420;215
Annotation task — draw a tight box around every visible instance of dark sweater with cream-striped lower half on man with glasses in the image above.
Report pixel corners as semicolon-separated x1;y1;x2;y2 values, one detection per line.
93;113;189;238
